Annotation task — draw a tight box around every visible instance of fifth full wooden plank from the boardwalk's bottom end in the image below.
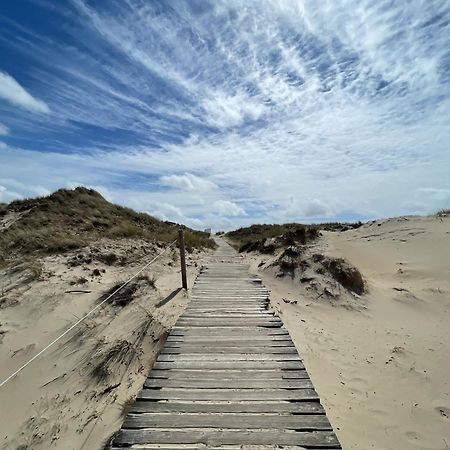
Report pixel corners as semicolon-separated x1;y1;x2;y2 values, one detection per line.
144;376;313;389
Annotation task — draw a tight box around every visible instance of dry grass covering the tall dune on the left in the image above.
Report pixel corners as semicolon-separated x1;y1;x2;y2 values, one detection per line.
0;187;215;265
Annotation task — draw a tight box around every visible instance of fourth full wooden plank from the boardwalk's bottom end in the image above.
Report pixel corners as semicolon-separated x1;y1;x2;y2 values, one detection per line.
137;388;319;401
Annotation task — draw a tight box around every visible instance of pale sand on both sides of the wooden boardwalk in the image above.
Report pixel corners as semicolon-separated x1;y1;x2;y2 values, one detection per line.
0;217;450;450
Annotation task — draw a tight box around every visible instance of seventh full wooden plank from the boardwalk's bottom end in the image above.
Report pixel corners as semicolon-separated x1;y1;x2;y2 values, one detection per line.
153;361;304;370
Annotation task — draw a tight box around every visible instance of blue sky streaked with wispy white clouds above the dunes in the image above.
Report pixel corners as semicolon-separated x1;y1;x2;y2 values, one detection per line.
0;0;450;230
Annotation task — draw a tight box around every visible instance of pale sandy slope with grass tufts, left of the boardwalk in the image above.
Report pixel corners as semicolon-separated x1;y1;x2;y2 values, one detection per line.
0;241;207;450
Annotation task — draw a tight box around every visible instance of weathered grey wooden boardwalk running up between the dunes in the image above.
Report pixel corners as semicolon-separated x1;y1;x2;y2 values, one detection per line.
112;240;341;450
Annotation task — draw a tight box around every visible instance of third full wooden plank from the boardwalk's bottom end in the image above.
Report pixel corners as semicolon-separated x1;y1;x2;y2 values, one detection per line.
130;399;325;414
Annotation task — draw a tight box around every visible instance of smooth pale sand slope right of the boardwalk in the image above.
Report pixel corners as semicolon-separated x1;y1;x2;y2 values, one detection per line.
246;217;450;450
